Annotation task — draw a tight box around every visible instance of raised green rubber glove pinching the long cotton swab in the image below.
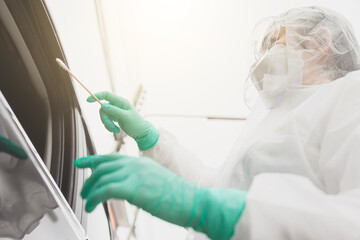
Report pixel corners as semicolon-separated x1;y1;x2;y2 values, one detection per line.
87;92;159;151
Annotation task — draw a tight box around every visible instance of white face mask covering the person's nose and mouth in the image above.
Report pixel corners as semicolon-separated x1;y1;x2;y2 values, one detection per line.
251;44;304;108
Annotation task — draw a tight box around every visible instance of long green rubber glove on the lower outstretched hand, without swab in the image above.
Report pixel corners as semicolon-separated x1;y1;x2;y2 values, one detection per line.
75;153;247;240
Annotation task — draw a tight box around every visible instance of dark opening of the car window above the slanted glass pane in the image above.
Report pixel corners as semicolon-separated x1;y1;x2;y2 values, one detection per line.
0;16;47;161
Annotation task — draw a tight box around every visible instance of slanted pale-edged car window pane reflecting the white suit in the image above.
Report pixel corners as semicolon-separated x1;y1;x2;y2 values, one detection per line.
0;92;86;240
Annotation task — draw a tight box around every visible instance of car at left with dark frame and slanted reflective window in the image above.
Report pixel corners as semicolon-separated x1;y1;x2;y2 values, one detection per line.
0;0;114;240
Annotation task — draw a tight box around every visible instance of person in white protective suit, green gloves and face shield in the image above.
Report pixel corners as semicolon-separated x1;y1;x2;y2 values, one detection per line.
75;7;360;240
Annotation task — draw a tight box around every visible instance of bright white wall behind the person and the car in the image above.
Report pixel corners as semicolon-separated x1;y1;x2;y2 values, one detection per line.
46;0;360;239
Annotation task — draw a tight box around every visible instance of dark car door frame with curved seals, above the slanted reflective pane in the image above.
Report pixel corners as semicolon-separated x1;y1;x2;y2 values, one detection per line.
0;0;110;239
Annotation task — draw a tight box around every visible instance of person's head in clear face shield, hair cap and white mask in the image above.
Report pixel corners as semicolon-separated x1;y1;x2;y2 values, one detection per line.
245;7;360;109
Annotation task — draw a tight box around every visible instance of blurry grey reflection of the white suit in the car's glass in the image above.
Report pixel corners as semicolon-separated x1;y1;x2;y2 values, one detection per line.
0;115;57;239
